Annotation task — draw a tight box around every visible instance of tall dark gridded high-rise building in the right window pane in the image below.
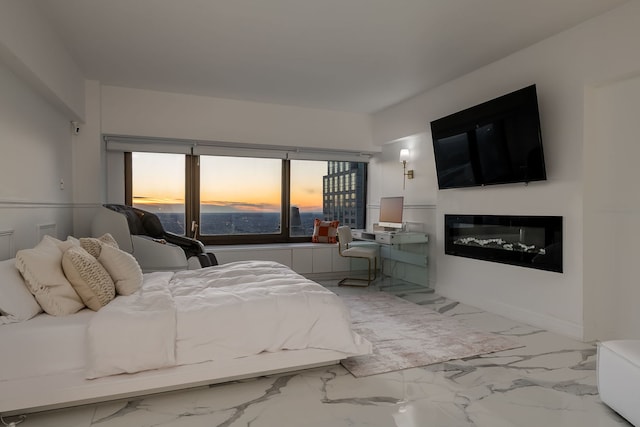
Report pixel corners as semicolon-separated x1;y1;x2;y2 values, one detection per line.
322;161;367;228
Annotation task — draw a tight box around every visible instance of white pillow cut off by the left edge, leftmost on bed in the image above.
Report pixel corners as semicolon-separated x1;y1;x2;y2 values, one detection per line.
0;259;42;325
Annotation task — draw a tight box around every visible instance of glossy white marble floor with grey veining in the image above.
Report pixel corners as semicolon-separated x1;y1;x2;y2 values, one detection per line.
3;279;631;427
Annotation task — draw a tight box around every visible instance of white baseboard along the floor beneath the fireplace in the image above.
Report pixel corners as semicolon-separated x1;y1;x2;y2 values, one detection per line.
436;288;584;341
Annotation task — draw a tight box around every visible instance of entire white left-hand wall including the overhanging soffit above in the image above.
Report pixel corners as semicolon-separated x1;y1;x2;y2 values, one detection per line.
0;0;85;256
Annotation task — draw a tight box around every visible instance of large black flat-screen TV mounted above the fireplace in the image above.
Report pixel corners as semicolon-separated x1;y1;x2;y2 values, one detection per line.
431;85;547;189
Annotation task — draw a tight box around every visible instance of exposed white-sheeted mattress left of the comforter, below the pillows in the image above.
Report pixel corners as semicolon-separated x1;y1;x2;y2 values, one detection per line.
0;309;95;380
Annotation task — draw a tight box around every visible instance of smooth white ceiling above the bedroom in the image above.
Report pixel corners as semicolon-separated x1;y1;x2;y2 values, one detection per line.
36;0;627;113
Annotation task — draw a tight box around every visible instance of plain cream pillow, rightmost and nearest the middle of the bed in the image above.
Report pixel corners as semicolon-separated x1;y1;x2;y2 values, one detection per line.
98;245;142;295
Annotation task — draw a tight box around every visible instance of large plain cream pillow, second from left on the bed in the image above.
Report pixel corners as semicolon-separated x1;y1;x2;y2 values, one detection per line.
16;236;84;316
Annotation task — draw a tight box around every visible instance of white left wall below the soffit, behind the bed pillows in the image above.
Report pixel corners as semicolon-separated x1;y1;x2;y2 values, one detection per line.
0;62;73;255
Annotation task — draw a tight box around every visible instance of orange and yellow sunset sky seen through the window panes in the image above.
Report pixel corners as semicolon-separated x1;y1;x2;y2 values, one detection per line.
133;153;327;212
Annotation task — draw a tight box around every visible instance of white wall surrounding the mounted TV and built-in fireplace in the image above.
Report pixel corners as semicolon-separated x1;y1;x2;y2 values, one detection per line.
373;2;640;338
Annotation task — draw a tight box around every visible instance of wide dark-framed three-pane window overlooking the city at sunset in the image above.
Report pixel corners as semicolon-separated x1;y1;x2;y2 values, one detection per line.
125;152;367;244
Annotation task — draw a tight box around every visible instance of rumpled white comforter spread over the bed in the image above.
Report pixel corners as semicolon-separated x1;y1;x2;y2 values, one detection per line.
86;261;366;378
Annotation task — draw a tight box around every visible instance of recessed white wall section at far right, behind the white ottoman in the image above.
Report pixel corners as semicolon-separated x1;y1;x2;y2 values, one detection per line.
584;76;640;339
